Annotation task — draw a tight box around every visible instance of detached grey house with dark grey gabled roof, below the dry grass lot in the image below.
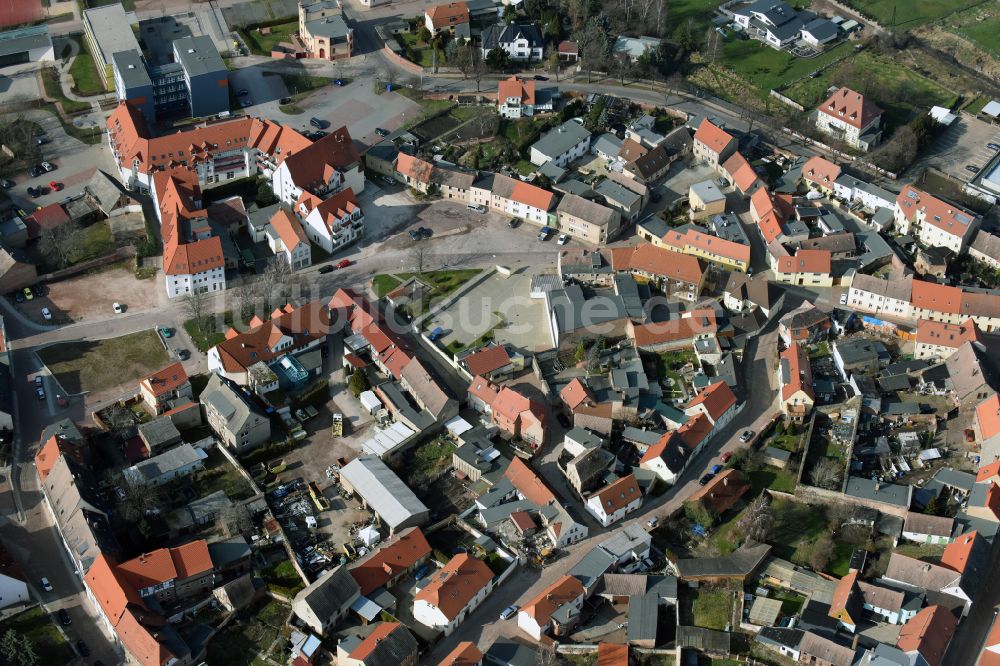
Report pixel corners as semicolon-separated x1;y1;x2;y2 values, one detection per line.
199;374;271;453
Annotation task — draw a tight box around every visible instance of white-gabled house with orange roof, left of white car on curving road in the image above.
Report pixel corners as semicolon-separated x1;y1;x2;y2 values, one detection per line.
413;553;493;636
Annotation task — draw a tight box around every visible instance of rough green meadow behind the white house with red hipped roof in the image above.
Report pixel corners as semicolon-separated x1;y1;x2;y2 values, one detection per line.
784;51;957;125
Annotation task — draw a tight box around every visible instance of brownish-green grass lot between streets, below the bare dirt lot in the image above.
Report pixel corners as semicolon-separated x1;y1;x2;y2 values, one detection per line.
38;331;170;394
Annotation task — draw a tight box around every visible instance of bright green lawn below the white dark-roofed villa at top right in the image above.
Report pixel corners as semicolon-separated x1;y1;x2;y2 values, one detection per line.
722;39;852;99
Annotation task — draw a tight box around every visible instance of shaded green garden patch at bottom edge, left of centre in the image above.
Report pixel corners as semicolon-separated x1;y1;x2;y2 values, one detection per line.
206;600;291;666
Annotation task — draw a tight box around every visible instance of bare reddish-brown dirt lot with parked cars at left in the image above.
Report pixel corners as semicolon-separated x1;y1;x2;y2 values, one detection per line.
15;263;166;324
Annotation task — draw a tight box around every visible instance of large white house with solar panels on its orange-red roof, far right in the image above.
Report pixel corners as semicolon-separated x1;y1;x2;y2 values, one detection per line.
894;185;980;254
